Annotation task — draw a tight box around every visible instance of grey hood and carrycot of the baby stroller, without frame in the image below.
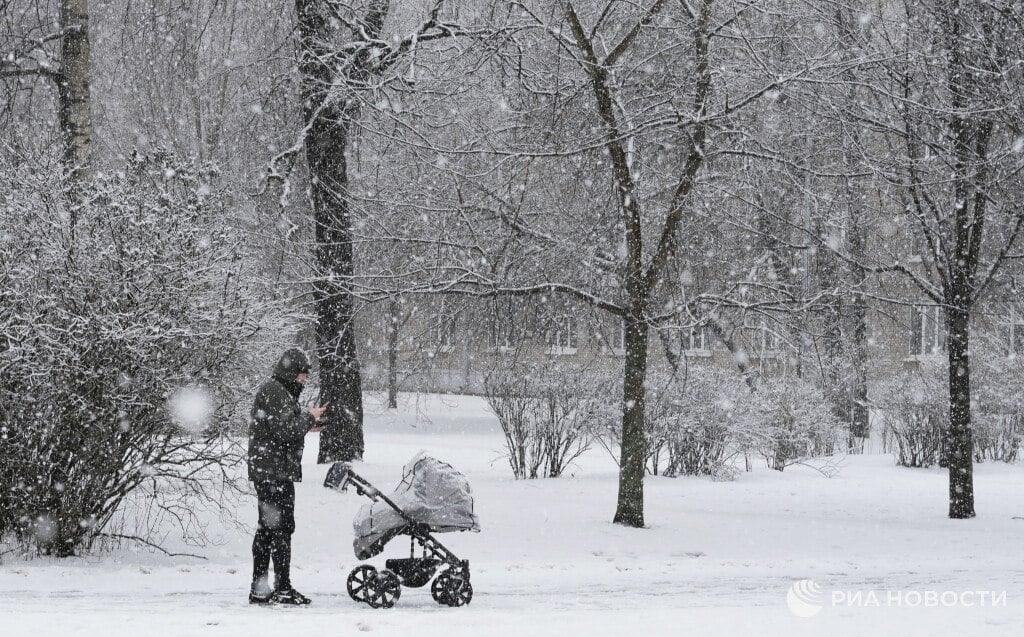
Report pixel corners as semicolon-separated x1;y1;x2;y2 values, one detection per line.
352;452;480;559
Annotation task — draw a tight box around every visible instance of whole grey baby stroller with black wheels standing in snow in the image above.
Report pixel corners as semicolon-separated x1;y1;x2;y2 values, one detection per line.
324;452;480;608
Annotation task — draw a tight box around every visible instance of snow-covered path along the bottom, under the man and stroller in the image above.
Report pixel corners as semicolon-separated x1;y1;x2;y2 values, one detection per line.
8;561;1024;636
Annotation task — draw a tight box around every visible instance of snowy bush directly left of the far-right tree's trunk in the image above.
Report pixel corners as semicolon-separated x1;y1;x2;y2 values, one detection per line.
878;365;949;467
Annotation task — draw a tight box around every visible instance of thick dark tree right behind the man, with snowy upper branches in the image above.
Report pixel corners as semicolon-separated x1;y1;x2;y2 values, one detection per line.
295;0;479;462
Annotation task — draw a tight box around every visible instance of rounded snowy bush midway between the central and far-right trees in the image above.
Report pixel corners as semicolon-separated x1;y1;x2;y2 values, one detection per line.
740;376;847;471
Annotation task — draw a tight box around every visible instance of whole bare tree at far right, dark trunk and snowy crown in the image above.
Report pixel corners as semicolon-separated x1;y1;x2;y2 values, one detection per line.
835;0;1024;518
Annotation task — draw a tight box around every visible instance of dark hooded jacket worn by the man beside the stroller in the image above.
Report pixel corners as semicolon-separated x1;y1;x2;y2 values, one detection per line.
249;349;315;482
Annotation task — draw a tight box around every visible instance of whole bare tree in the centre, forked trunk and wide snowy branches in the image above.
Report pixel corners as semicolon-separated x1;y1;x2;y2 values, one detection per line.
344;0;823;526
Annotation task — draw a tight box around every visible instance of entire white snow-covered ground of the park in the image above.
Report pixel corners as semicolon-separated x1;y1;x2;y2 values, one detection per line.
0;396;1024;637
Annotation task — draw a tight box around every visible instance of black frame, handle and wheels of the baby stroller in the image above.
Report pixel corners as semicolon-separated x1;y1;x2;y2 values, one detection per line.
327;463;473;608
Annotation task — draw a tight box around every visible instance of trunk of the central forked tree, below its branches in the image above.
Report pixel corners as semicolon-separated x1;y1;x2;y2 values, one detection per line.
612;312;649;527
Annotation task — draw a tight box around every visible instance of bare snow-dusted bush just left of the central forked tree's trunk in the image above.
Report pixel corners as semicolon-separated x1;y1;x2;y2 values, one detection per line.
484;364;609;479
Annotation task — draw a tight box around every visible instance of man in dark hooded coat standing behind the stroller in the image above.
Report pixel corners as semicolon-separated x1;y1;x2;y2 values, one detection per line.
249;348;326;605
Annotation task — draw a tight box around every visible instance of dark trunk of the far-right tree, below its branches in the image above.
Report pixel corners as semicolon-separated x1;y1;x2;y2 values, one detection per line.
945;306;975;519
